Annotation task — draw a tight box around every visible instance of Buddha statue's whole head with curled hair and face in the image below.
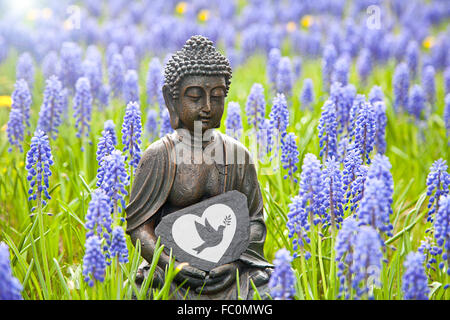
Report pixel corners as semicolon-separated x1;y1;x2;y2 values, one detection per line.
163;36;231;132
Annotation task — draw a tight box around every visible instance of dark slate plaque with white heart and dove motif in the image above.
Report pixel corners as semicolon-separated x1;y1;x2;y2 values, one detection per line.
155;190;250;271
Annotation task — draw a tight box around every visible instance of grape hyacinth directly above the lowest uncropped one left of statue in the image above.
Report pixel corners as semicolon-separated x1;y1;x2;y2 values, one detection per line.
85;189;112;245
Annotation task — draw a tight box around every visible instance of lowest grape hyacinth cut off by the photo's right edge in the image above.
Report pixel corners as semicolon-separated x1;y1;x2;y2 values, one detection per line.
434;194;450;276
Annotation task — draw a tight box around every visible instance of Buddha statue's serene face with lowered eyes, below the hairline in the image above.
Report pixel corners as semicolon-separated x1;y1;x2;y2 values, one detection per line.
174;76;226;132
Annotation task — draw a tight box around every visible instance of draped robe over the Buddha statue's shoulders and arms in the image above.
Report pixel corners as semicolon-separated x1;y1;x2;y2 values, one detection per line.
125;131;273;298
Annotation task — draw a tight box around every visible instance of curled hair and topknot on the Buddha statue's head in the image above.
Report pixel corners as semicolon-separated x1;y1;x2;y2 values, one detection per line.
164;35;231;99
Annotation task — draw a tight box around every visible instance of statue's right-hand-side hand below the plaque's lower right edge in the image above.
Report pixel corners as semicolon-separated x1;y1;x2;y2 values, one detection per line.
196;262;239;294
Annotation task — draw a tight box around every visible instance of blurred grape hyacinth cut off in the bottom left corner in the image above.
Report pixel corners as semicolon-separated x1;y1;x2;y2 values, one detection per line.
0;242;23;300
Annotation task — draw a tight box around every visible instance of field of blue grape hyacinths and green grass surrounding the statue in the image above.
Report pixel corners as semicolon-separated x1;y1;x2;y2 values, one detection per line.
0;0;450;299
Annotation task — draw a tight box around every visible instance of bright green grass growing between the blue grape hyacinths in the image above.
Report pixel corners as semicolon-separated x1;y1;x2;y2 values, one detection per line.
0;42;450;300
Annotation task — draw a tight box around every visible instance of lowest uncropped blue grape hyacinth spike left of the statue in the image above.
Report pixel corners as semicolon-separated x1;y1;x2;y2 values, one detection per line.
83;235;106;287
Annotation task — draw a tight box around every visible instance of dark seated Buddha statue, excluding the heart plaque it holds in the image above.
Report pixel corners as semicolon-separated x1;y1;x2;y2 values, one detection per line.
125;36;273;299
